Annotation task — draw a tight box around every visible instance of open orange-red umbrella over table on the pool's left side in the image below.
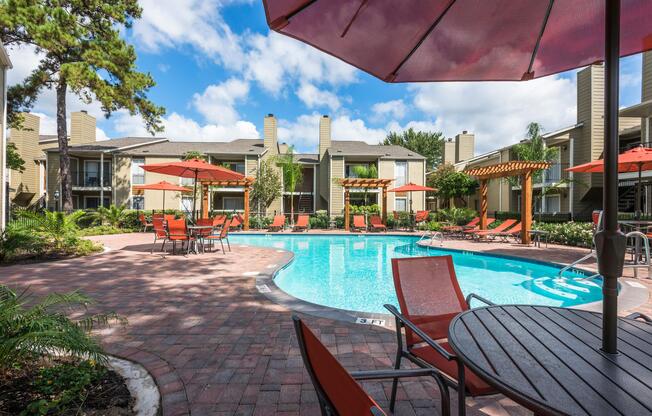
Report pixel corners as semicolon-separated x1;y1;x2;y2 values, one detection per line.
141;159;244;221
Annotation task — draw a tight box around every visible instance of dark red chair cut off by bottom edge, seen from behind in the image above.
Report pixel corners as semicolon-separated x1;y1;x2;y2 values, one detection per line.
292;315;433;416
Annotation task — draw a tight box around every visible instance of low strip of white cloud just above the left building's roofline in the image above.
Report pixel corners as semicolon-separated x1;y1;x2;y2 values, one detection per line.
113;110;260;142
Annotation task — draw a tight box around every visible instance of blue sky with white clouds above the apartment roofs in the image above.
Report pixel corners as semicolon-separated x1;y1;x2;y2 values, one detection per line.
9;0;641;153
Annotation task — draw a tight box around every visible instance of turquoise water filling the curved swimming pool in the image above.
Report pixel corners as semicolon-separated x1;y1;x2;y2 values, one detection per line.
229;234;602;313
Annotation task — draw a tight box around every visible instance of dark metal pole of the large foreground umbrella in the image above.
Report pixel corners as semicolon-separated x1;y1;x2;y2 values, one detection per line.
595;0;625;354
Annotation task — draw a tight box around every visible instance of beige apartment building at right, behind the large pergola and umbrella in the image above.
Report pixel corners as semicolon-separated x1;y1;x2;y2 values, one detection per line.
454;52;652;219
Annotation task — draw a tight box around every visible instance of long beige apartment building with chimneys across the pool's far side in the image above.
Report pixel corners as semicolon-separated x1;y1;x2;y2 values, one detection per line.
11;113;425;216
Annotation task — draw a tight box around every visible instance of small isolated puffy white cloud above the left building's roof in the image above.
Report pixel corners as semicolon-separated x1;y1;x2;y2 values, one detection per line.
192;78;249;124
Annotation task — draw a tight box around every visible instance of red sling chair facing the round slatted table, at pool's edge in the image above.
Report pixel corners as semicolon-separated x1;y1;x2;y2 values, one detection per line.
385;255;495;415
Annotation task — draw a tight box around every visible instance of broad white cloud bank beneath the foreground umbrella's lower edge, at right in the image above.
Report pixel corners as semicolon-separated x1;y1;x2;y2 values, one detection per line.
409;76;577;154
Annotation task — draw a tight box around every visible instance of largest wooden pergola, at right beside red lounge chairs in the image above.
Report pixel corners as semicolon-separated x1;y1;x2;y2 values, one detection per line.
464;160;550;244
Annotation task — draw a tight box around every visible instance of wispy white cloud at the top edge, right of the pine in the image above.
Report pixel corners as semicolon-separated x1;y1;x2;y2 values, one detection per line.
133;0;244;69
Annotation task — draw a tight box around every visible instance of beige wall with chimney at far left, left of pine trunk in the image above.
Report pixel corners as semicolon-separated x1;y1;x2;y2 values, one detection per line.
9;113;42;202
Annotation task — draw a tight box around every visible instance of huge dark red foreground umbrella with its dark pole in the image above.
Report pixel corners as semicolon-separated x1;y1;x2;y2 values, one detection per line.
263;0;652;353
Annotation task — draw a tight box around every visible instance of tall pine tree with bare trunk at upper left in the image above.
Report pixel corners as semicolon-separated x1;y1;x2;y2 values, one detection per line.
0;0;165;211
